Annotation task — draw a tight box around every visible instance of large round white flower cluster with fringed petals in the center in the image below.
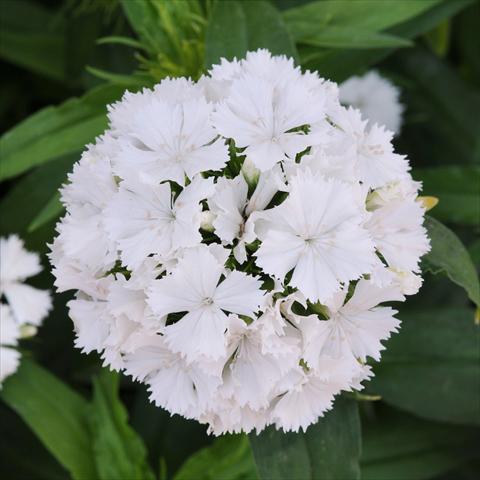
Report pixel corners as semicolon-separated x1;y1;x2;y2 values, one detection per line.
51;50;429;434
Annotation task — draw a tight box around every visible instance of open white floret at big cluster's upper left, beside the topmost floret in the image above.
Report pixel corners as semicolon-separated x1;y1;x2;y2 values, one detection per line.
114;93;228;186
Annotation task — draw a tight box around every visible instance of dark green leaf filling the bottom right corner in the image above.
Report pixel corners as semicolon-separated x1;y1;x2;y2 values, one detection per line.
361;409;479;480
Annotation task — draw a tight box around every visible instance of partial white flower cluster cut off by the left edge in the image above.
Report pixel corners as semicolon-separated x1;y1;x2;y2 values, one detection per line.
0;235;52;388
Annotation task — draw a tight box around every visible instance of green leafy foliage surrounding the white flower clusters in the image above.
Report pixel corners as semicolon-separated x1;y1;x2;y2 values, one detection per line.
0;0;480;480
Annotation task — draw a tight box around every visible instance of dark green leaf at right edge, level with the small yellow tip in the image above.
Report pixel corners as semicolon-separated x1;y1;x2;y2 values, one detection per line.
414;165;480;226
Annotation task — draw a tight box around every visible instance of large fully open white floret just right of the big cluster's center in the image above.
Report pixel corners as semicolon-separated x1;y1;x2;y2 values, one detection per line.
256;172;376;301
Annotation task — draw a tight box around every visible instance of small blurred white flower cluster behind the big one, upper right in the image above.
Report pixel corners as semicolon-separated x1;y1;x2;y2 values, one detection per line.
340;70;404;134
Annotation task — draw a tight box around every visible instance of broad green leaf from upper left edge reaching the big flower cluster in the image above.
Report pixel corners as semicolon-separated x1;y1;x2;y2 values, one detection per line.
0;85;123;180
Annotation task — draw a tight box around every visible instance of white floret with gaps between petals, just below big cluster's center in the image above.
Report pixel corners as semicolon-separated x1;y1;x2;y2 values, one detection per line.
149;246;263;360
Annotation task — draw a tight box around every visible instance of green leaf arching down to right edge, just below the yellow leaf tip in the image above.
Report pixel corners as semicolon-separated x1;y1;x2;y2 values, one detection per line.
422;215;480;306
